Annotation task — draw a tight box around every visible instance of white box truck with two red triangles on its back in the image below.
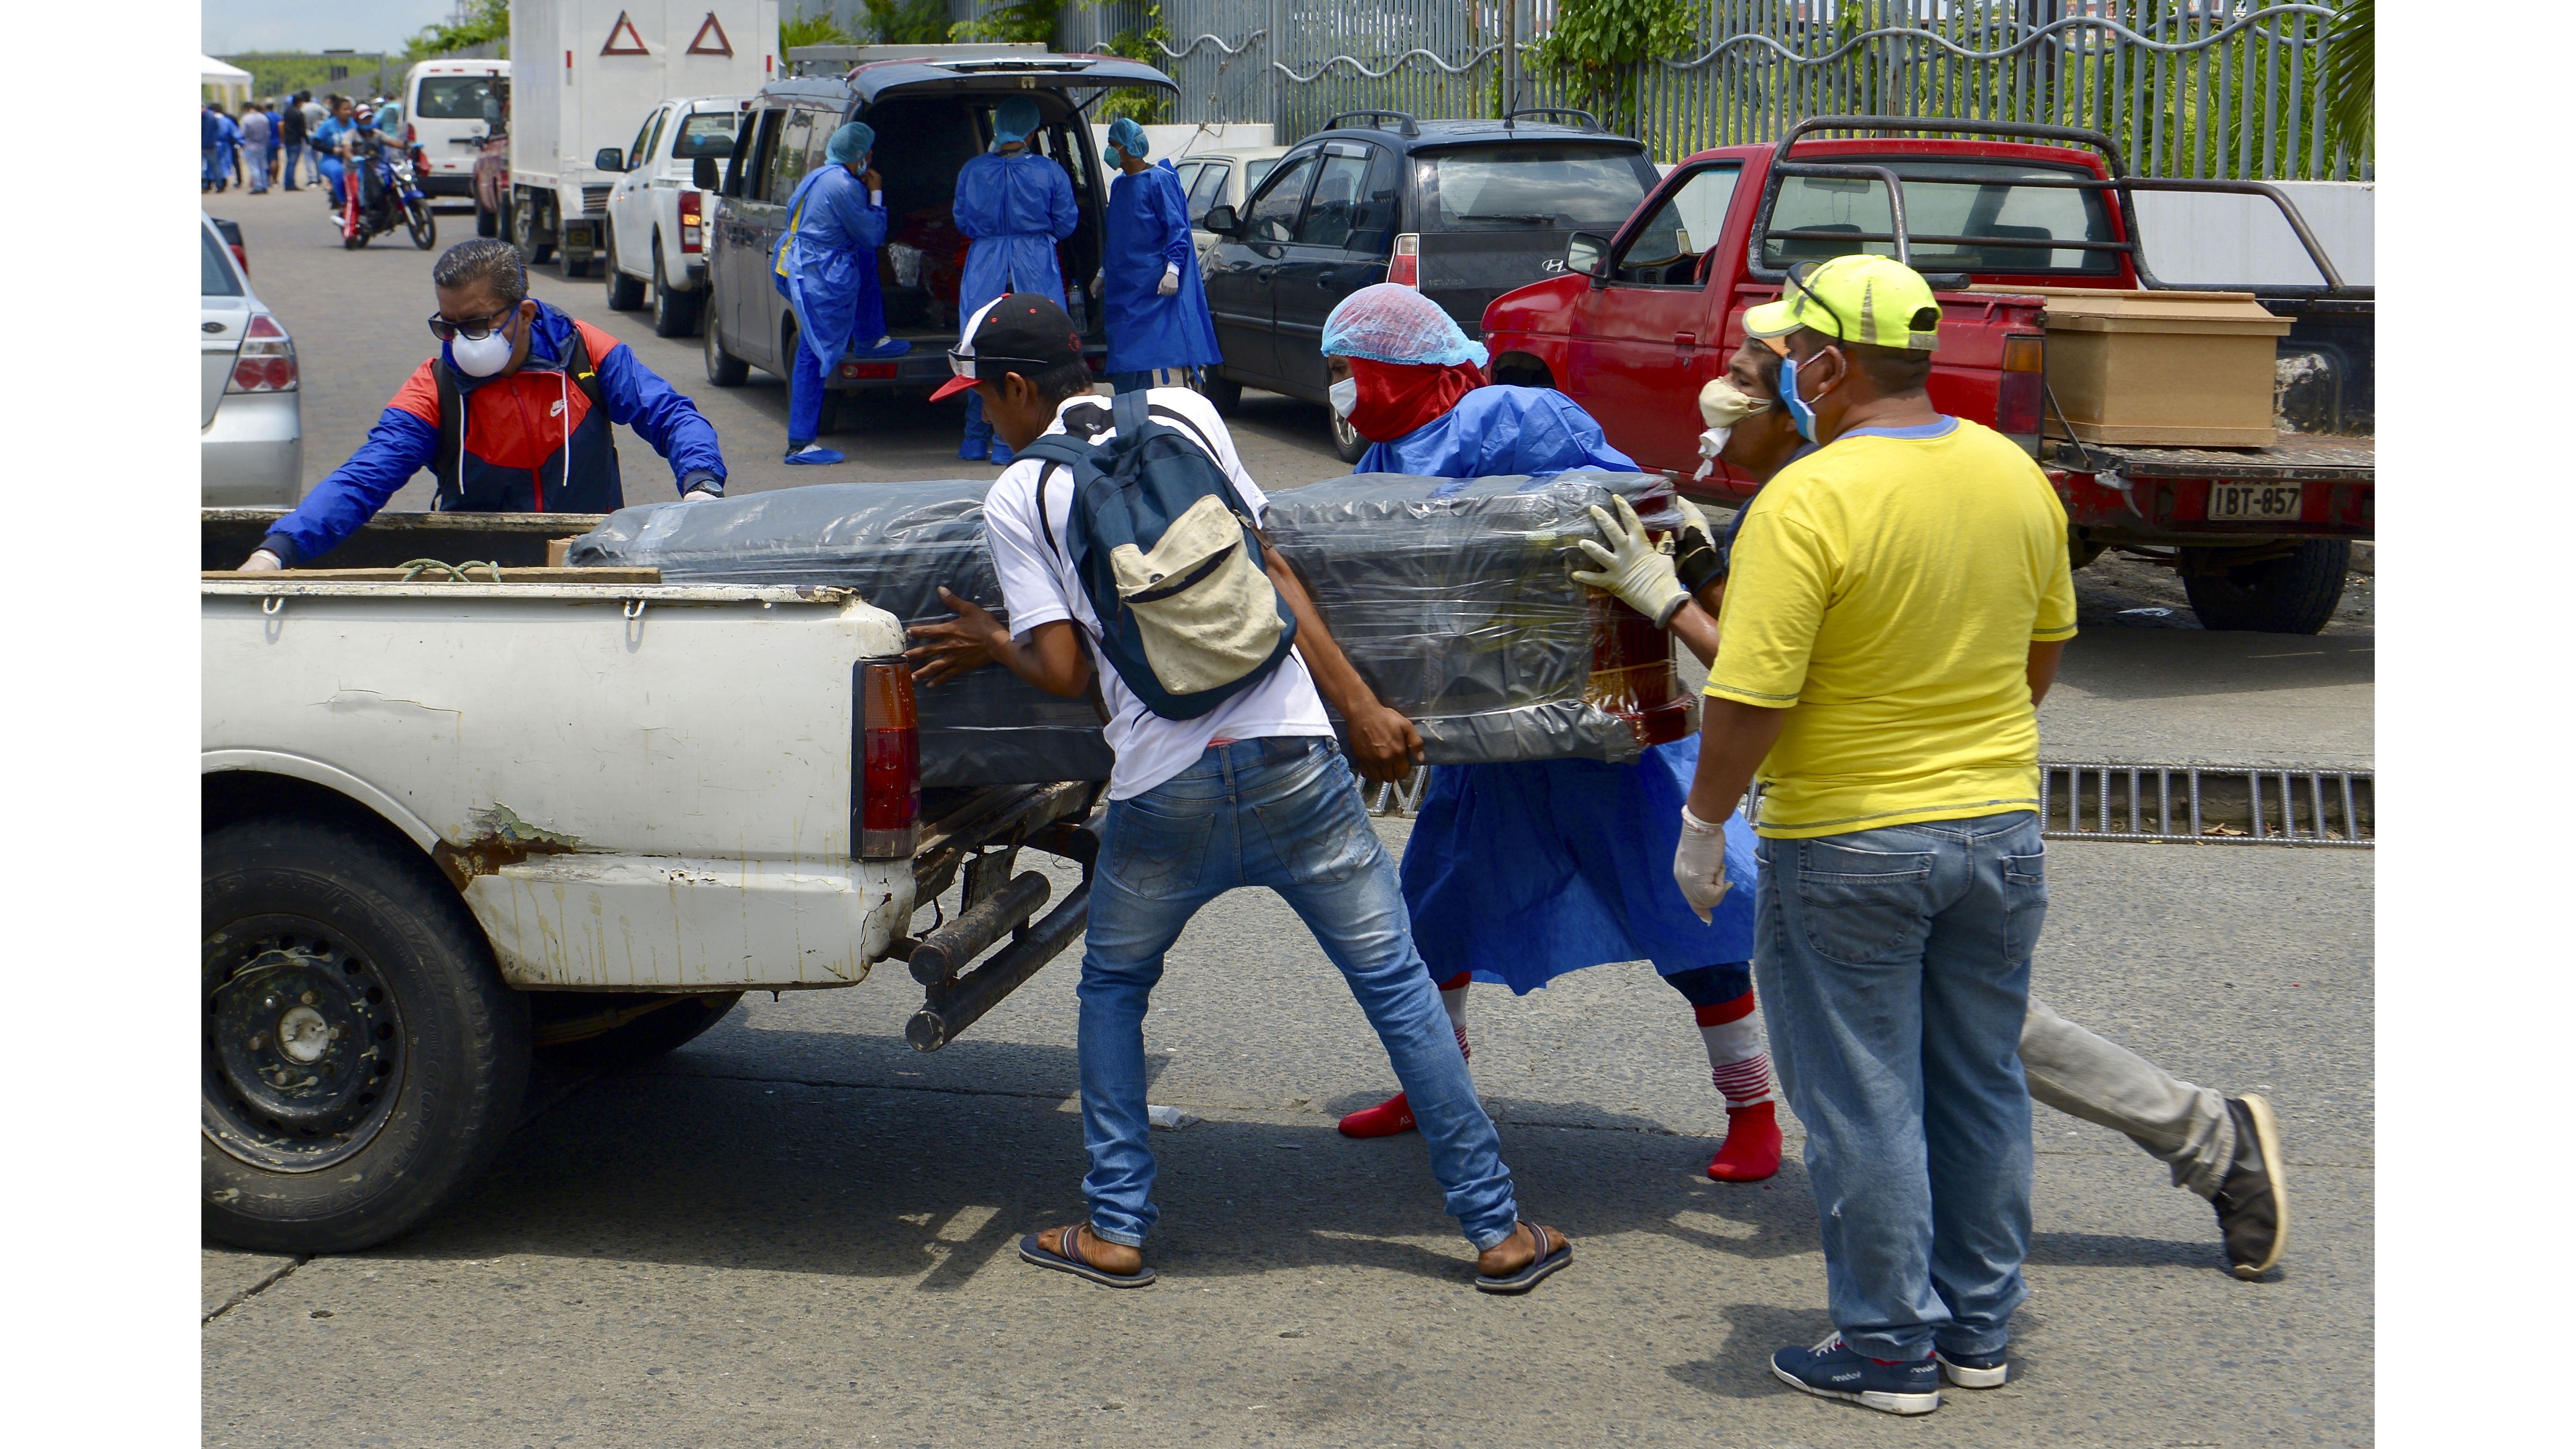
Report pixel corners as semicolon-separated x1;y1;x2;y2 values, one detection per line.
507;0;781;276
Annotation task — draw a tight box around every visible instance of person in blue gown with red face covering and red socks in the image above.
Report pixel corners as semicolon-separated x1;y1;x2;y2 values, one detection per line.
1324;284;1780;1181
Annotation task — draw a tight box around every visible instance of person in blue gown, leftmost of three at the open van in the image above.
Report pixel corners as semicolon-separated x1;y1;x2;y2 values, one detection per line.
770;121;912;464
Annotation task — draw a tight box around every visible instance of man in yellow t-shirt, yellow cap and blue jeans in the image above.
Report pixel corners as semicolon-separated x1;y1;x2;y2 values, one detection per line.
1674;255;2076;1413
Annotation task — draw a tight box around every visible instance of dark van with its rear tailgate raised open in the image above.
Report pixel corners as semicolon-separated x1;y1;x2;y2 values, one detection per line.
700;46;1180;431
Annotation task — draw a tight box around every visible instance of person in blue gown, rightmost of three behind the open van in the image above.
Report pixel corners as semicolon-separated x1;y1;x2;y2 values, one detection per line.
1100;116;1221;392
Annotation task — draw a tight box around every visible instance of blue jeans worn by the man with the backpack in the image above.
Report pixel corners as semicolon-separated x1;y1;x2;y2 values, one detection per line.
1077;735;1520;1251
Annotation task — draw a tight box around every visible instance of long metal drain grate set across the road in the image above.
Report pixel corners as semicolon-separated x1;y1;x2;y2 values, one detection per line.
1360;761;2378;848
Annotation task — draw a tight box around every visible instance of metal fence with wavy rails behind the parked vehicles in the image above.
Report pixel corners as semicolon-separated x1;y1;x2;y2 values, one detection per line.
1061;0;2370;180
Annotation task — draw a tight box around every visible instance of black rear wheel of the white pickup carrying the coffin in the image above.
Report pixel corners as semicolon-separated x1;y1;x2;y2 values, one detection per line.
201;815;528;1253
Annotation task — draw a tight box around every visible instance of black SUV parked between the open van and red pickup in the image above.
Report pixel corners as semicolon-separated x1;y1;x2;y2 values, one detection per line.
1201;111;1656;461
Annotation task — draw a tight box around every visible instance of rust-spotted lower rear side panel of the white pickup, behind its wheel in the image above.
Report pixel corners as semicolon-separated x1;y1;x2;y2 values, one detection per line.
464;854;912;990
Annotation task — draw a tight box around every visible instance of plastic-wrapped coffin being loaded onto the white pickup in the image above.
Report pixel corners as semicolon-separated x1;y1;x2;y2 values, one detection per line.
567;472;1669;786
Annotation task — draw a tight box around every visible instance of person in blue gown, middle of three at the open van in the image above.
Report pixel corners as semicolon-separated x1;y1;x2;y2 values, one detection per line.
956;95;1082;464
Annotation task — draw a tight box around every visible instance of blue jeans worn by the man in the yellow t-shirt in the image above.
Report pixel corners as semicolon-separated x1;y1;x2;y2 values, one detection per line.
1754;810;2048;1361
